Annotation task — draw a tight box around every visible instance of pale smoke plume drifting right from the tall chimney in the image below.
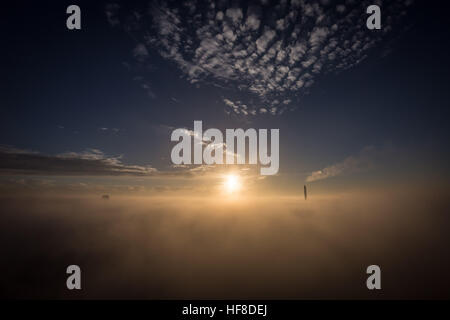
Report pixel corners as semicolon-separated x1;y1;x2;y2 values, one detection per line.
306;146;382;182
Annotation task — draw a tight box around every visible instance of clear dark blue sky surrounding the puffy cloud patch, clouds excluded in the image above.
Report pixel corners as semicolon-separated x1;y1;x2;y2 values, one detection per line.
0;1;450;189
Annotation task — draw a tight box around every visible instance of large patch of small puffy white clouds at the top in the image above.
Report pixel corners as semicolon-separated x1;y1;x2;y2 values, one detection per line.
105;0;412;116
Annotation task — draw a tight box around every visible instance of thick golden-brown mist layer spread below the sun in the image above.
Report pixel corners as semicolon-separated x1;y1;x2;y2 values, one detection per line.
0;190;450;299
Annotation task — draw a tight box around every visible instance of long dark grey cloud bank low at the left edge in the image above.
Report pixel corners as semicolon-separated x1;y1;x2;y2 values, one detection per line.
0;147;157;176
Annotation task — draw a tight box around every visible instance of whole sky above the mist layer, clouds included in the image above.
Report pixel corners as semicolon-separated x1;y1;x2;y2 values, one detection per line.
0;1;449;198
